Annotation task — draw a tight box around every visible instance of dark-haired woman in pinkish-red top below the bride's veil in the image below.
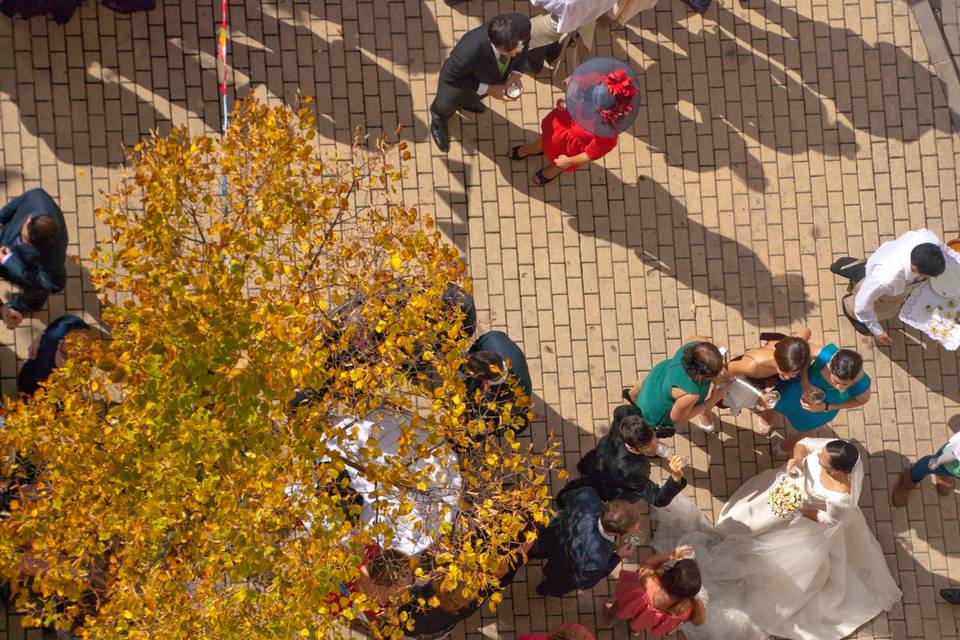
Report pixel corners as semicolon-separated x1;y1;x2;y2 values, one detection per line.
606;546;707;638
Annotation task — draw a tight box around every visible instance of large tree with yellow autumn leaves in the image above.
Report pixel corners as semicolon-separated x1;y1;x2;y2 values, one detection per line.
0;101;558;638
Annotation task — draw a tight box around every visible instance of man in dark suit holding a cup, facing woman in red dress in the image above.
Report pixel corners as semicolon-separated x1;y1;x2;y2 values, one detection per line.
430;13;530;153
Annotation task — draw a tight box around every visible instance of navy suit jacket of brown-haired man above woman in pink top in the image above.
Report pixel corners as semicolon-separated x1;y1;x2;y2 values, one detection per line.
529;487;620;589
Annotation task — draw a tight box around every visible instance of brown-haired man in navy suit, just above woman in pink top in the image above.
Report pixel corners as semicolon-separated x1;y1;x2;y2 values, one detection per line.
527;487;640;597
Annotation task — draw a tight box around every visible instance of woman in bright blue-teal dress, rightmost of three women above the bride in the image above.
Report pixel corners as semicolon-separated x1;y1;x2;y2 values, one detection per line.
774;344;870;453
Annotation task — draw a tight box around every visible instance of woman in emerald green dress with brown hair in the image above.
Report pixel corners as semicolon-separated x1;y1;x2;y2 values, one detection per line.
624;336;730;435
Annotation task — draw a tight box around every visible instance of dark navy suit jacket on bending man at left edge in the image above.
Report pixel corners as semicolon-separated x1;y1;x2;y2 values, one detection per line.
0;189;67;313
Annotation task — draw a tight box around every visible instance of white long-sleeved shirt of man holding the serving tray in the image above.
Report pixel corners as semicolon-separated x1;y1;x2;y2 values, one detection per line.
853;229;943;336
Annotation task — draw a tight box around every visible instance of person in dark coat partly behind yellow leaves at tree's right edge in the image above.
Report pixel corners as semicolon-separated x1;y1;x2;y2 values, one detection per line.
464;331;533;435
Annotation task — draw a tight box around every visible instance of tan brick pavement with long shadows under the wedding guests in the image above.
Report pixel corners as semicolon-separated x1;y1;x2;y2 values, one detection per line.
0;0;960;640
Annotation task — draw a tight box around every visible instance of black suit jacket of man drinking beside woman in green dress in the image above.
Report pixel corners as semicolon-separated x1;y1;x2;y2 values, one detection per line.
571;404;687;507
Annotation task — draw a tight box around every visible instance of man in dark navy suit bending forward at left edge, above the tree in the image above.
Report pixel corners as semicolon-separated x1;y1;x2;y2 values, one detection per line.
0;189;67;329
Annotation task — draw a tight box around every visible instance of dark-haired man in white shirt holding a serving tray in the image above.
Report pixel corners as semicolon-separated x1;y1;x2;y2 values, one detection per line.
830;229;946;346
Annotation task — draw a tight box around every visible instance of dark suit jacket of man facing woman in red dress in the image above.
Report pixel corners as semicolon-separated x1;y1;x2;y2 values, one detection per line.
440;13;530;93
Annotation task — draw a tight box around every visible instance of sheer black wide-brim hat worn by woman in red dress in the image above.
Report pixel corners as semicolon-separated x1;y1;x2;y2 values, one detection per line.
566;58;640;137
